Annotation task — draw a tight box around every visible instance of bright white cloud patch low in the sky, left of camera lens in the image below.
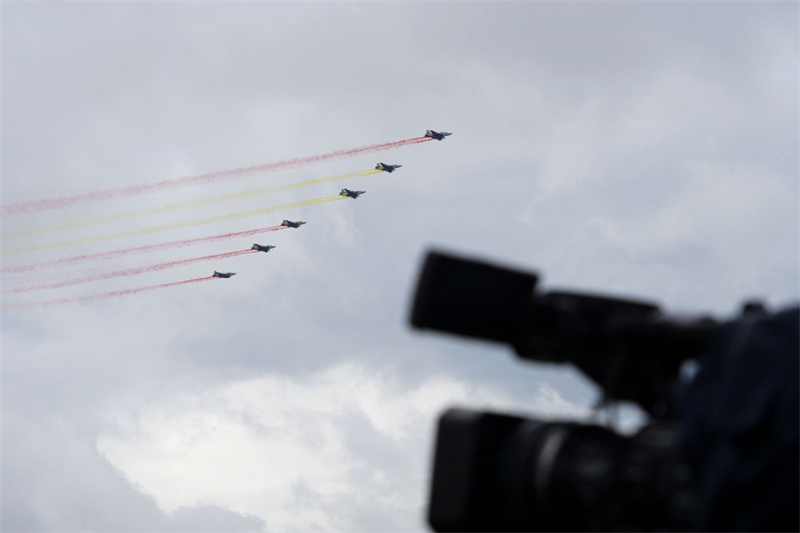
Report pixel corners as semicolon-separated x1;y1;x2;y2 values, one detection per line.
98;362;585;531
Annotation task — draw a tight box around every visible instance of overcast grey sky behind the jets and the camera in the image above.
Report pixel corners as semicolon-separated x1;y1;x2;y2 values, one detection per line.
0;2;800;531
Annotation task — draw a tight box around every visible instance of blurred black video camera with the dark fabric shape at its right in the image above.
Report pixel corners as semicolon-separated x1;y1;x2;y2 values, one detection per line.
411;252;800;531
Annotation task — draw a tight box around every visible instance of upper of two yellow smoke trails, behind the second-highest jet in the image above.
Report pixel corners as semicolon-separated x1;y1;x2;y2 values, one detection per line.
3;170;383;240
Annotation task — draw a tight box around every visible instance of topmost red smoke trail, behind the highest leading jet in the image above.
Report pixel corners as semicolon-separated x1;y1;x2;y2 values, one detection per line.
0;137;431;215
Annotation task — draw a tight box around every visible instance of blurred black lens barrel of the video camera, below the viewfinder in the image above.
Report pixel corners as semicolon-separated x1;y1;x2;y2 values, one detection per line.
428;409;693;531
